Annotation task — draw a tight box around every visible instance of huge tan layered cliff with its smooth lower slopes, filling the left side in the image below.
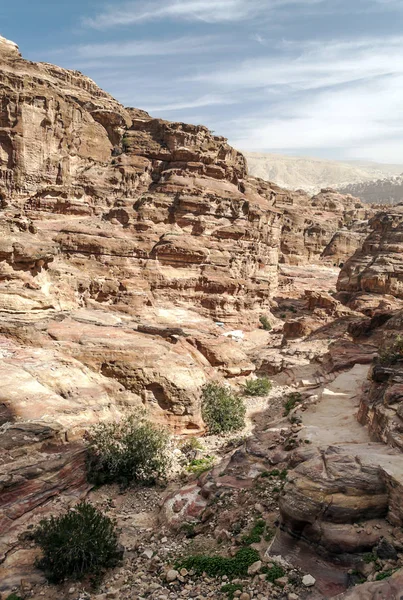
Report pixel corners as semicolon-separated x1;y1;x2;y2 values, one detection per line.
0;38;281;556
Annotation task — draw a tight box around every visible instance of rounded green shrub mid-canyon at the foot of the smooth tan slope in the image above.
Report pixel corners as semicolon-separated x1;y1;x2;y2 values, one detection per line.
202;383;246;434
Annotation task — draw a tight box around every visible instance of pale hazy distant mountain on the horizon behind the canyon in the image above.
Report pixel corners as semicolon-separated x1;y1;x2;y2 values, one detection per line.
244;152;403;203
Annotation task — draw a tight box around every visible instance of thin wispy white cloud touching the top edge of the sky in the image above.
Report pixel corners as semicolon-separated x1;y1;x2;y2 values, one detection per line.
84;0;328;29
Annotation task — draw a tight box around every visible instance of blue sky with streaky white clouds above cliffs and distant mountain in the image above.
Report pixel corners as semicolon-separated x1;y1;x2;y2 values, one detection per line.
0;0;403;164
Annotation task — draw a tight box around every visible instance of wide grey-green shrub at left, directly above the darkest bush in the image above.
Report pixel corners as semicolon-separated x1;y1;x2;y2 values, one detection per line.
87;411;170;486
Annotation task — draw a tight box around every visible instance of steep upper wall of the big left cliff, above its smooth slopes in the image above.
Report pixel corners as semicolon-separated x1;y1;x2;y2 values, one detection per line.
0;37;280;320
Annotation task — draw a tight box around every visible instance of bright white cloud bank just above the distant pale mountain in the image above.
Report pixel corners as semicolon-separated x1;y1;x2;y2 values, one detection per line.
231;69;403;163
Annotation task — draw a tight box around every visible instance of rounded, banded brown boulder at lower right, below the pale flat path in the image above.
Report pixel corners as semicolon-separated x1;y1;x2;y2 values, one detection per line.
280;444;403;556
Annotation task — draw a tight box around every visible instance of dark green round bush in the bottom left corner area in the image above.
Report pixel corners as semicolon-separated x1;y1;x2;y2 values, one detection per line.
33;502;122;583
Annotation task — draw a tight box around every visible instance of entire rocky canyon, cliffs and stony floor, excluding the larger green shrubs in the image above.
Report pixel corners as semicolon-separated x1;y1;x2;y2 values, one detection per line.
0;37;403;600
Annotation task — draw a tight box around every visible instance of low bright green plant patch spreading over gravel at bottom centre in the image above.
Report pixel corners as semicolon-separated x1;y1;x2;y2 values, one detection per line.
175;547;259;579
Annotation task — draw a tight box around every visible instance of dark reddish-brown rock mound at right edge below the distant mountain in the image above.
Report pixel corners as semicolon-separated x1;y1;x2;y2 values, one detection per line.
337;205;403;306
